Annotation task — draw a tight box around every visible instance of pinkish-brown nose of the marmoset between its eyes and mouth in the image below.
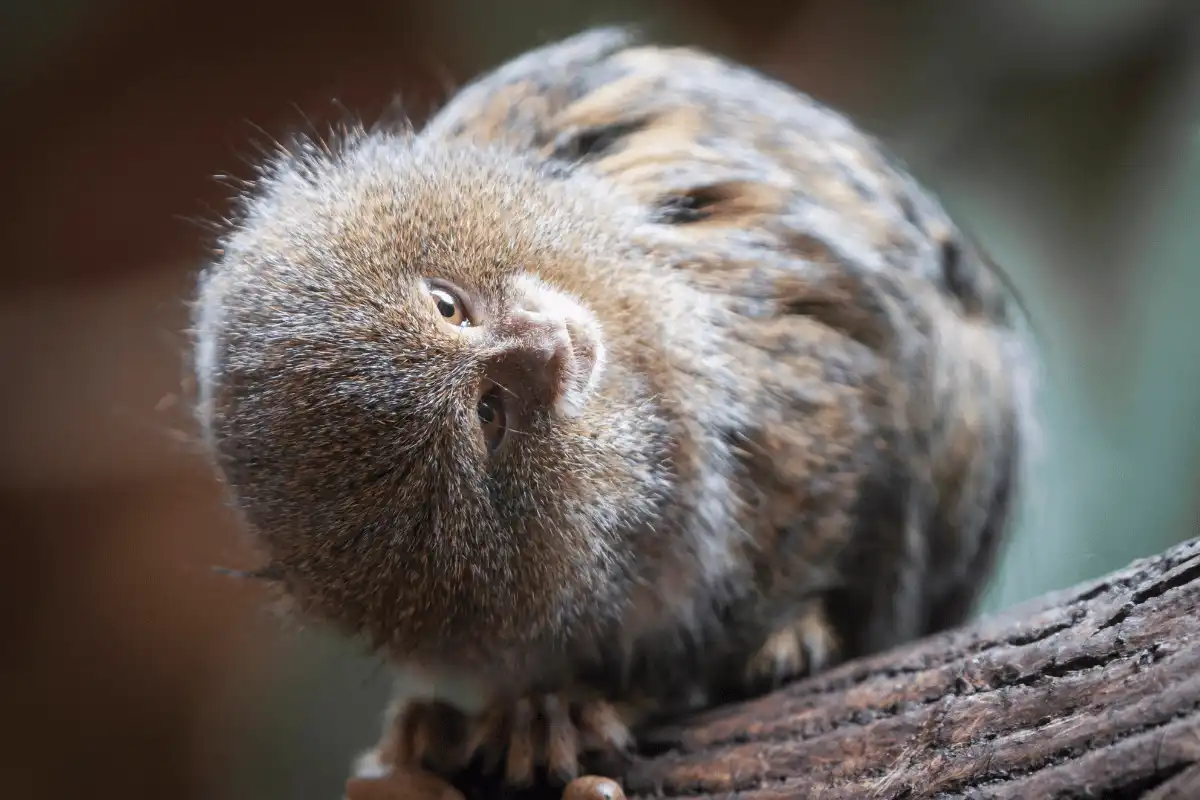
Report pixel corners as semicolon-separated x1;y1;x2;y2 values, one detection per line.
487;309;574;410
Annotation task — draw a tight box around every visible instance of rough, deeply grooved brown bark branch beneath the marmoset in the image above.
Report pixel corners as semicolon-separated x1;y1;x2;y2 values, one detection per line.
624;540;1200;800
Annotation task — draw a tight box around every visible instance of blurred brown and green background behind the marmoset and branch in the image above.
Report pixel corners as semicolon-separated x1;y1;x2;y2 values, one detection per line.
0;0;1200;800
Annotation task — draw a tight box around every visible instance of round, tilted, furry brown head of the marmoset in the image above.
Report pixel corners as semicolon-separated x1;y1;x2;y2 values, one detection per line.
194;132;670;681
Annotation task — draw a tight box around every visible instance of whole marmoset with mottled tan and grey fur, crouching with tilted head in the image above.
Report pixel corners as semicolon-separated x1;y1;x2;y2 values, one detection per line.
194;30;1033;784
